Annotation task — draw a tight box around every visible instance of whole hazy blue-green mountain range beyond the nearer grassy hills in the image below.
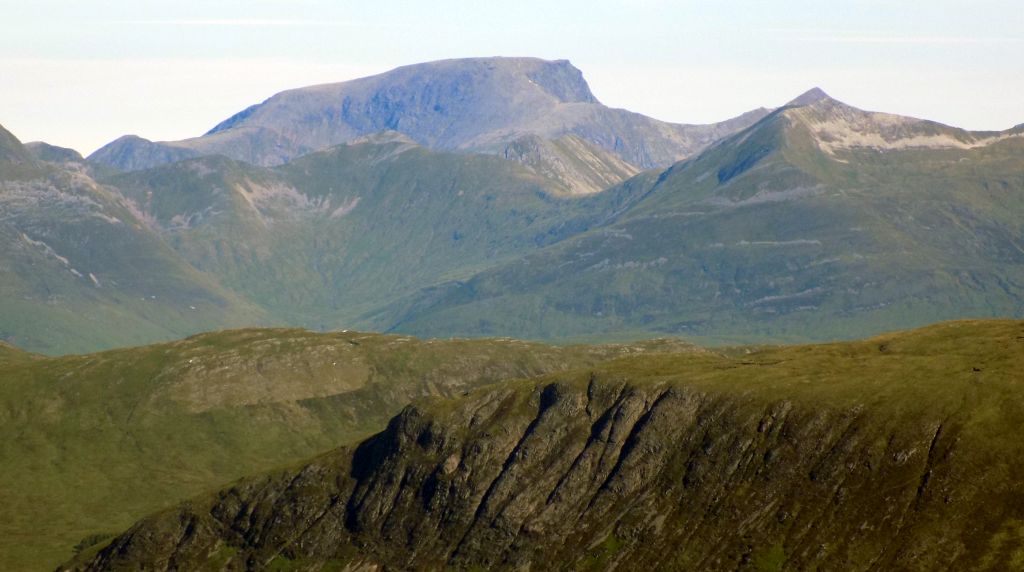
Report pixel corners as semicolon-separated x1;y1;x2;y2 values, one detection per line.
0;58;1024;353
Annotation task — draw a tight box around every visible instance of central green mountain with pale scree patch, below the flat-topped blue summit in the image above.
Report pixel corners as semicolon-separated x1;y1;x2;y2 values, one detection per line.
104;133;647;328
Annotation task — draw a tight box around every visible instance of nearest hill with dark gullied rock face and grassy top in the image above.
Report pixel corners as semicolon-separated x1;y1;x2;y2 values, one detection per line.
60;320;1024;571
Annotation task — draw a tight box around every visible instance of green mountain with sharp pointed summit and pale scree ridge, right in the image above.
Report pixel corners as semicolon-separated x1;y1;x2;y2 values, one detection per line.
376;90;1024;341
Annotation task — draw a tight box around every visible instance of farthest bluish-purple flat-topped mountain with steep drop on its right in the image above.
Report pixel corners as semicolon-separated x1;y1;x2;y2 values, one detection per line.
89;57;767;182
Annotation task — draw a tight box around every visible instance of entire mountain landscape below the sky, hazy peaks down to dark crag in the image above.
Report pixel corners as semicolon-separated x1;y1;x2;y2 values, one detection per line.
6;58;1024;571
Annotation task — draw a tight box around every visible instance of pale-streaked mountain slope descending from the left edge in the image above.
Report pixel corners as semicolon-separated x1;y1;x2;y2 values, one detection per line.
0;124;262;353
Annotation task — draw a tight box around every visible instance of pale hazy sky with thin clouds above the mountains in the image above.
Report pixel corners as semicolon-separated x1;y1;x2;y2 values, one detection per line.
0;0;1024;152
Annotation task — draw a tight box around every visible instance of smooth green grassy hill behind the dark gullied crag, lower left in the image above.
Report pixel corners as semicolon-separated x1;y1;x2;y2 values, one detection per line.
0;329;685;570
